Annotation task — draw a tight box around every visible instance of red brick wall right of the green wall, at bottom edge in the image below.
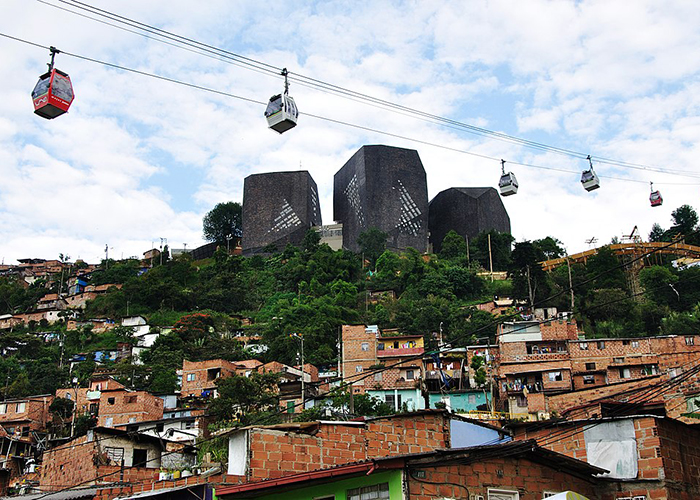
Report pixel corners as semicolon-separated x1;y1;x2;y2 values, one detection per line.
408;458;601;500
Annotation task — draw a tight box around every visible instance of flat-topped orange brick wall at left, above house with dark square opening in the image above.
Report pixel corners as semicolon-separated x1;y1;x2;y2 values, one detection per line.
97;390;163;427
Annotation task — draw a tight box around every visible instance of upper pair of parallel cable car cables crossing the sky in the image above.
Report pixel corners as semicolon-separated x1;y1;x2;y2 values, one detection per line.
37;0;696;177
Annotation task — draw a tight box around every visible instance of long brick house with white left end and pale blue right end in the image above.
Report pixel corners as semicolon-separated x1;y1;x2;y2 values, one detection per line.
228;410;510;481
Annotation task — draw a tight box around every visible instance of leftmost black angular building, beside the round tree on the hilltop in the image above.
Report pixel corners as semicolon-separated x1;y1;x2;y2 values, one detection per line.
241;170;321;255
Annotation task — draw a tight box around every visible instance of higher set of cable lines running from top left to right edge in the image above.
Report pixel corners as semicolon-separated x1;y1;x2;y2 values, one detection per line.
23;0;699;177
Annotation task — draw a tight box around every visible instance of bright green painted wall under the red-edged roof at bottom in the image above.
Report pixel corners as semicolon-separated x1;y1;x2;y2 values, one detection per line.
249;469;403;500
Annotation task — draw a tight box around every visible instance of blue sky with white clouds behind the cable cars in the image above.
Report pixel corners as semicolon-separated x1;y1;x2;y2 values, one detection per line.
0;0;700;264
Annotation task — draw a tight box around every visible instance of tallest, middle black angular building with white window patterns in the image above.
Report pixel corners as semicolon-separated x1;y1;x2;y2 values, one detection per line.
333;146;428;252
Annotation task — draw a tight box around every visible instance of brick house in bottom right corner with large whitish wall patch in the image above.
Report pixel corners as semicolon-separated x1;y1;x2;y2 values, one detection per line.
512;415;700;500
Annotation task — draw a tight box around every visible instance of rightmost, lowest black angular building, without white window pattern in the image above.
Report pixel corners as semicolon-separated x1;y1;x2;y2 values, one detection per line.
428;187;510;253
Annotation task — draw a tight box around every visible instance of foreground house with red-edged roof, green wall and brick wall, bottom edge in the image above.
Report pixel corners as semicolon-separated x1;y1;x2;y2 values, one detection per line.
216;442;606;500
